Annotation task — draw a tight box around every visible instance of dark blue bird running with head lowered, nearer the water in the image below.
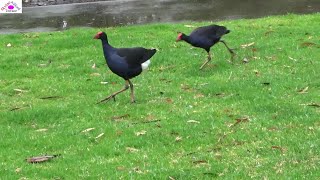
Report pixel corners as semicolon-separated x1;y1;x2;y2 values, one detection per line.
176;25;235;69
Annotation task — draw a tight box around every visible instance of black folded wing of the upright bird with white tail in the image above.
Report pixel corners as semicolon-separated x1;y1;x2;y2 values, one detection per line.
116;47;156;66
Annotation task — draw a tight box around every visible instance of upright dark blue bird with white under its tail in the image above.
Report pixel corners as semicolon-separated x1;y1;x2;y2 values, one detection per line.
94;32;156;103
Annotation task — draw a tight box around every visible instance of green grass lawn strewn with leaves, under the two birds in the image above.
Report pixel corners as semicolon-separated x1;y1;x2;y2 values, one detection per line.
0;13;320;179
